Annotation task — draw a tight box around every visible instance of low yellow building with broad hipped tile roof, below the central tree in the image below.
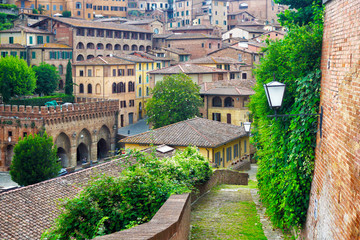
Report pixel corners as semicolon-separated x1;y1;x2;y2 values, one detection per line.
120;117;250;167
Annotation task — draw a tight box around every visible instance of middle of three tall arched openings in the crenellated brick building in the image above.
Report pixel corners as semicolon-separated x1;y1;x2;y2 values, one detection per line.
76;128;92;165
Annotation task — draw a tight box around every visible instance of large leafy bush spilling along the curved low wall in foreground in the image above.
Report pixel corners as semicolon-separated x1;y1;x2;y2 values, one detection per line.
42;147;212;239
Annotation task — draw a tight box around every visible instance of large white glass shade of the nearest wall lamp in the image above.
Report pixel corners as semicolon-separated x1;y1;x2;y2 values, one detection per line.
264;81;286;108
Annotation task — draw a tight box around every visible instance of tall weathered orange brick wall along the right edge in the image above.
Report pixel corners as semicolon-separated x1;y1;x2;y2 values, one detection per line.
302;0;360;239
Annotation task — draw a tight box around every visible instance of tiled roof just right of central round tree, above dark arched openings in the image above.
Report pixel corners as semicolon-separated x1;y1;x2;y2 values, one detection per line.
200;80;255;96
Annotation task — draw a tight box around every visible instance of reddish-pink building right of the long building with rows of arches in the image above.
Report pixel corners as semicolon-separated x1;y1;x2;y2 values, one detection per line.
165;33;222;59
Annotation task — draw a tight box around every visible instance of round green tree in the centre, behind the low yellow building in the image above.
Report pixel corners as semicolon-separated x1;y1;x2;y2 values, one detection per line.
146;73;203;128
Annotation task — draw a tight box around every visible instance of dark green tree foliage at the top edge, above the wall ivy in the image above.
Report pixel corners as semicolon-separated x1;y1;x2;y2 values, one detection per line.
275;0;323;27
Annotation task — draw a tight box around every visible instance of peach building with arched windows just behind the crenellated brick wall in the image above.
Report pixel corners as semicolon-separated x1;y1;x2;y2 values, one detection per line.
73;57;138;127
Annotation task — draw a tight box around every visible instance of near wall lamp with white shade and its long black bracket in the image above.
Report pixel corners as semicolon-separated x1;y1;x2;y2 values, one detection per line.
264;81;323;138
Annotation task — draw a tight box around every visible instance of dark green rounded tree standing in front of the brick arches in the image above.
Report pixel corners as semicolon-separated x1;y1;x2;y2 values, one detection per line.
10;132;61;186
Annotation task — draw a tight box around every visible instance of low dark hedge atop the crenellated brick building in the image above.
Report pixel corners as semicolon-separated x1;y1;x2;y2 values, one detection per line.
8;94;75;106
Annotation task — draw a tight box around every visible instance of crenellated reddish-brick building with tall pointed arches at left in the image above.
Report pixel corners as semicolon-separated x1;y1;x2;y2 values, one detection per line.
0;99;119;171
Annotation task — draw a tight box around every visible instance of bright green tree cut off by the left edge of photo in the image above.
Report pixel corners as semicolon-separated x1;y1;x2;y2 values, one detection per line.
0;56;36;102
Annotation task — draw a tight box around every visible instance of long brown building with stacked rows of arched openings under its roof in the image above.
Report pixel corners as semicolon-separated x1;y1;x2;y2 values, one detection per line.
33;18;152;61
